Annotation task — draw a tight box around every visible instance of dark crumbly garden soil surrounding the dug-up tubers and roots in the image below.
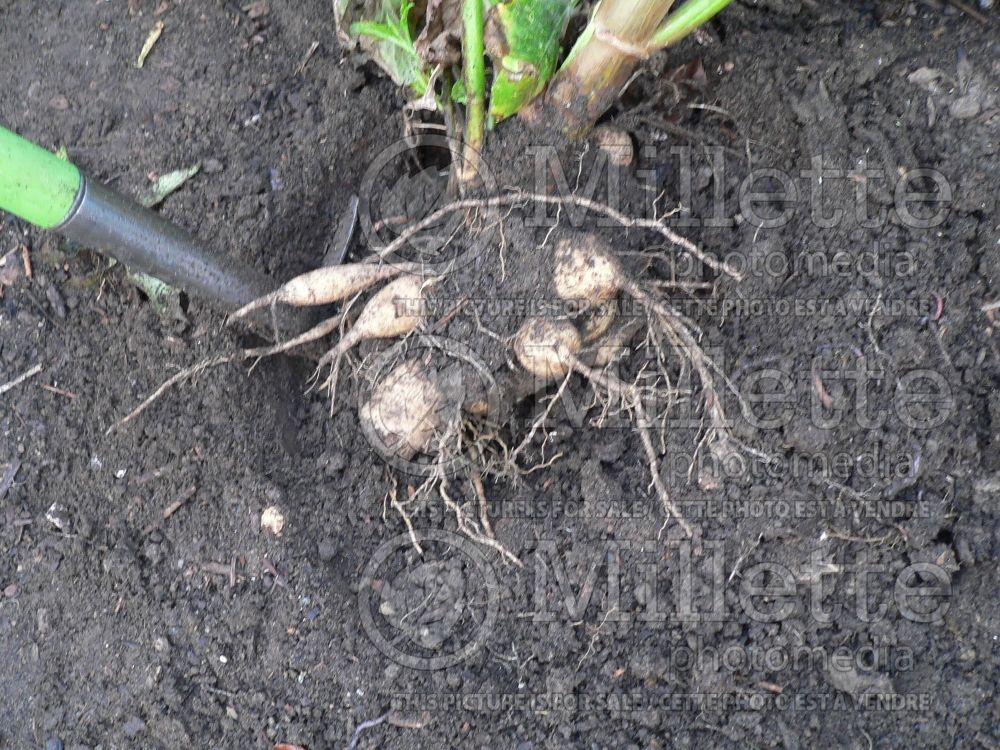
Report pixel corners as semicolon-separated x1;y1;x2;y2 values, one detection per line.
0;0;1000;750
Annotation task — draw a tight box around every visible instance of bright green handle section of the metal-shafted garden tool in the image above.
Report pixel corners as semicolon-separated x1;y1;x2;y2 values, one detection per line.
0;126;82;229
